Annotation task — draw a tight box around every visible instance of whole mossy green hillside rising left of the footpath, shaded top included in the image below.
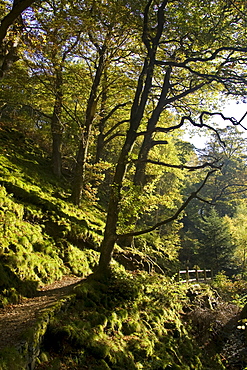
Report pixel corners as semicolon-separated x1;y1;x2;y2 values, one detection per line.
0;127;104;305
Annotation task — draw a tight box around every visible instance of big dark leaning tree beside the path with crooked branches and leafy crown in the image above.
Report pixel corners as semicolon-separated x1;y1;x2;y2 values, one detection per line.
93;0;246;274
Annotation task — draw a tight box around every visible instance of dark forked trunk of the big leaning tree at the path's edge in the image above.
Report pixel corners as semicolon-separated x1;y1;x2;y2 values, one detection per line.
94;0;167;278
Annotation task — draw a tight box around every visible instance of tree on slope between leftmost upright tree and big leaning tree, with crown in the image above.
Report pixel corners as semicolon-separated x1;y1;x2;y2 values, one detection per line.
71;1;139;205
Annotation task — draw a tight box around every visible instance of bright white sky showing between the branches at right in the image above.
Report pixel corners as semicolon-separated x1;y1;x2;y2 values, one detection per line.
183;101;247;149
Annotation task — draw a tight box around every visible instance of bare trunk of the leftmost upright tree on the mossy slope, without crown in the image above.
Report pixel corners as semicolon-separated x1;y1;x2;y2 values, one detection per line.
51;65;63;177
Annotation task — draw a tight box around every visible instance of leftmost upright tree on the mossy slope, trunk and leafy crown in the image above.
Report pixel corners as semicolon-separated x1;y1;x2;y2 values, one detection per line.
26;1;85;177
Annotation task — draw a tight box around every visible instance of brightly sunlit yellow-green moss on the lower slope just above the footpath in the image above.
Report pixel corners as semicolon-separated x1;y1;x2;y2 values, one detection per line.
0;165;102;305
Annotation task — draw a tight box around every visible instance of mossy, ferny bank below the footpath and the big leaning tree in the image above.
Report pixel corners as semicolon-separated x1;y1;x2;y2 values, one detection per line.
37;269;227;370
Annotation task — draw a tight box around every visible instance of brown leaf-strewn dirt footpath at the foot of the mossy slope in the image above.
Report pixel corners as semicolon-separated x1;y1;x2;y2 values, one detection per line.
0;276;82;349
